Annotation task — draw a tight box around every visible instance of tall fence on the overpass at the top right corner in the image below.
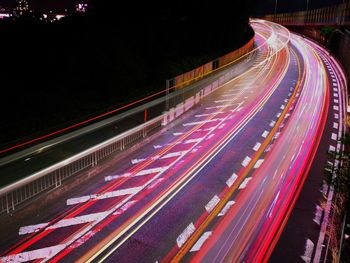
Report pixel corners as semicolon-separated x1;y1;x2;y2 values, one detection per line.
263;1;350;26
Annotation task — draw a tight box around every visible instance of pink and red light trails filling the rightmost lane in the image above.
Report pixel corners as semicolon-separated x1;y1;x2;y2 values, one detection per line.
186;23;329;262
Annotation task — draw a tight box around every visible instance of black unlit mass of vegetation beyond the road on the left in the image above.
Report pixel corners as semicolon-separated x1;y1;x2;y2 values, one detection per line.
0;0;253;151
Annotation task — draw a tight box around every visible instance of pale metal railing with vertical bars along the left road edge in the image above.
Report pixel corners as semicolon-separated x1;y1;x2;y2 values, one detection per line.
0;116;163;213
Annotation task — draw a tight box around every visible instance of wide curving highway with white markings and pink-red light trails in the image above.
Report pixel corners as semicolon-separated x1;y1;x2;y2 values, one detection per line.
0;20;341;262
